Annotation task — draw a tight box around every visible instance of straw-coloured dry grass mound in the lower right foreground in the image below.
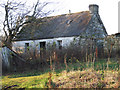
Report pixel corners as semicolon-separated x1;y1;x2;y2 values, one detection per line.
53;69;119;88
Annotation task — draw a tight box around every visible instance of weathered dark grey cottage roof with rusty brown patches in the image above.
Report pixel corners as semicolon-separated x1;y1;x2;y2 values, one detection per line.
14;11;91;40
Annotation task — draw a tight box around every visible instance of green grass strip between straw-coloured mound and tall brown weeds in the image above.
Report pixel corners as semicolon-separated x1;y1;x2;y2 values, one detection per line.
65;59;119;71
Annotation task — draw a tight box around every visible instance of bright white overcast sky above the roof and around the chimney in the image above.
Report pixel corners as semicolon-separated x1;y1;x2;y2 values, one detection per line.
0;0;119;35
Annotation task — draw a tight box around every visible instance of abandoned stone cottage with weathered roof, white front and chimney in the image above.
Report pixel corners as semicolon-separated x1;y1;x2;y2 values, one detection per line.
12;4;107;53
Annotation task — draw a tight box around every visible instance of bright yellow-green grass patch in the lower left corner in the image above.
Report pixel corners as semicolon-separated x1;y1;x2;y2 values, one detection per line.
2;73;48;88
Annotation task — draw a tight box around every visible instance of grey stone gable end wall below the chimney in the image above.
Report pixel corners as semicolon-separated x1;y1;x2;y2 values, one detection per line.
85;14;107;39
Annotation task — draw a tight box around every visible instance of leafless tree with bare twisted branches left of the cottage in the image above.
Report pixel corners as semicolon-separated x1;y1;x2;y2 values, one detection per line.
1;0;53;48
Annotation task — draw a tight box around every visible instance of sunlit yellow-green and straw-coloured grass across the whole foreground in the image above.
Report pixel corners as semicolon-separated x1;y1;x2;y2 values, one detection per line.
2;68;120;88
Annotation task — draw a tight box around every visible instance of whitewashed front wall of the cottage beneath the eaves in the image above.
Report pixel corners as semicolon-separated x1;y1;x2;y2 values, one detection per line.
12;37;75;53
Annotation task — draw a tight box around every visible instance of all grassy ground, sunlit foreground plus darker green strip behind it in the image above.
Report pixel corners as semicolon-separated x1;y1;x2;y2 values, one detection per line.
2;60;119;88
